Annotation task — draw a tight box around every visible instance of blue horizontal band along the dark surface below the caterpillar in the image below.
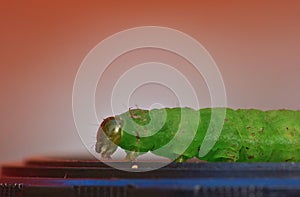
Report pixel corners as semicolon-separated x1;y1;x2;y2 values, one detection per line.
54;178;300;188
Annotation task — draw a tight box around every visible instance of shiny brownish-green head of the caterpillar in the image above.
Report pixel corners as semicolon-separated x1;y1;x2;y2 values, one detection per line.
95;117;122;158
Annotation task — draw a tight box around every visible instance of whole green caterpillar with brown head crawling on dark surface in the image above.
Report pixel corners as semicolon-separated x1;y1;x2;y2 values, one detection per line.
95;108;300;162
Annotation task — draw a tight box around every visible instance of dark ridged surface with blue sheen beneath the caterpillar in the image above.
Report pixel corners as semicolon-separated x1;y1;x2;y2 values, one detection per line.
0;158;300;197
